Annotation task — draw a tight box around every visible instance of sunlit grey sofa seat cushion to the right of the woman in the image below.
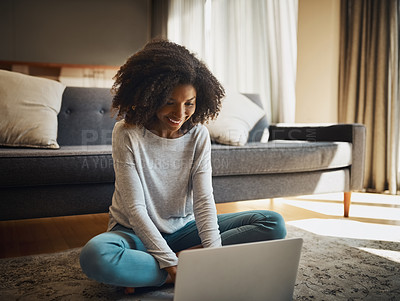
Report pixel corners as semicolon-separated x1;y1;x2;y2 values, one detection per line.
211;141;352;176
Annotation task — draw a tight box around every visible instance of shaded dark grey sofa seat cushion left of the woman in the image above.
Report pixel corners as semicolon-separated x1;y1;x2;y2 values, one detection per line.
0;145;114;187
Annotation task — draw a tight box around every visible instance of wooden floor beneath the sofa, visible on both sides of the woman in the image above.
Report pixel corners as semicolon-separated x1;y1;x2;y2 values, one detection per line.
0;193;400;258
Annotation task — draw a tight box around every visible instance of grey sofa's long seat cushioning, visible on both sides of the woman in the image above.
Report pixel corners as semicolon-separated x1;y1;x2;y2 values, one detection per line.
0;141;352;187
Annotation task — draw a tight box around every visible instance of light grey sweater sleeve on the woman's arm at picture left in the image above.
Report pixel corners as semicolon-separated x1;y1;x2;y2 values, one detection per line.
113;124;178;269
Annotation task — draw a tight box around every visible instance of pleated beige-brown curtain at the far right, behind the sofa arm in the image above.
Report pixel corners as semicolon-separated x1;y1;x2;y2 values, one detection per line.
339;0;400;193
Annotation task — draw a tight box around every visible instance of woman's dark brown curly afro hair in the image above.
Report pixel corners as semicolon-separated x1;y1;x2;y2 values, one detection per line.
112;40;225;130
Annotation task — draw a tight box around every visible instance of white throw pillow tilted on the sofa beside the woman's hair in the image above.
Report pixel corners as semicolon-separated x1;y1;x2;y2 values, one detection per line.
206;88;265;145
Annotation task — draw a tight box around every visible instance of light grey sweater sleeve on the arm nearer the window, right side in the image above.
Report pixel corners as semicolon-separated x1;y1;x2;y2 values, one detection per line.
192;127;221;248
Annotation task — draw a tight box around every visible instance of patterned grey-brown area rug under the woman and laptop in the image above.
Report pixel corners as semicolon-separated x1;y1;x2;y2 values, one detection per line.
0;225;400;301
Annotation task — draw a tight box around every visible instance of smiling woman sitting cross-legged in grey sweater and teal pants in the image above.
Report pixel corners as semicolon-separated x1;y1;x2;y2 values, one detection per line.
80;40;286;293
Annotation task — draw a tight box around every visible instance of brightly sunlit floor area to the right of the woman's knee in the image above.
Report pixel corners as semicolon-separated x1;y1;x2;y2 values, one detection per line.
218;193;400;263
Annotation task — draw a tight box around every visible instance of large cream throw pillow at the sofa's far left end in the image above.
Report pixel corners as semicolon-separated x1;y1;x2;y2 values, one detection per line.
0;70;65;148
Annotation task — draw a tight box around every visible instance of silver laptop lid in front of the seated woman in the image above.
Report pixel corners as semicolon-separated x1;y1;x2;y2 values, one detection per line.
174;238;303;301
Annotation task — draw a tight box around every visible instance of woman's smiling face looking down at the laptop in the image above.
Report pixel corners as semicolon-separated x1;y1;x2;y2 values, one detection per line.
149;85;196;138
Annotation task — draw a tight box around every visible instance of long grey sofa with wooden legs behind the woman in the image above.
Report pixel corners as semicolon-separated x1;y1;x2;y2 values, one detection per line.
0;87;365;220
